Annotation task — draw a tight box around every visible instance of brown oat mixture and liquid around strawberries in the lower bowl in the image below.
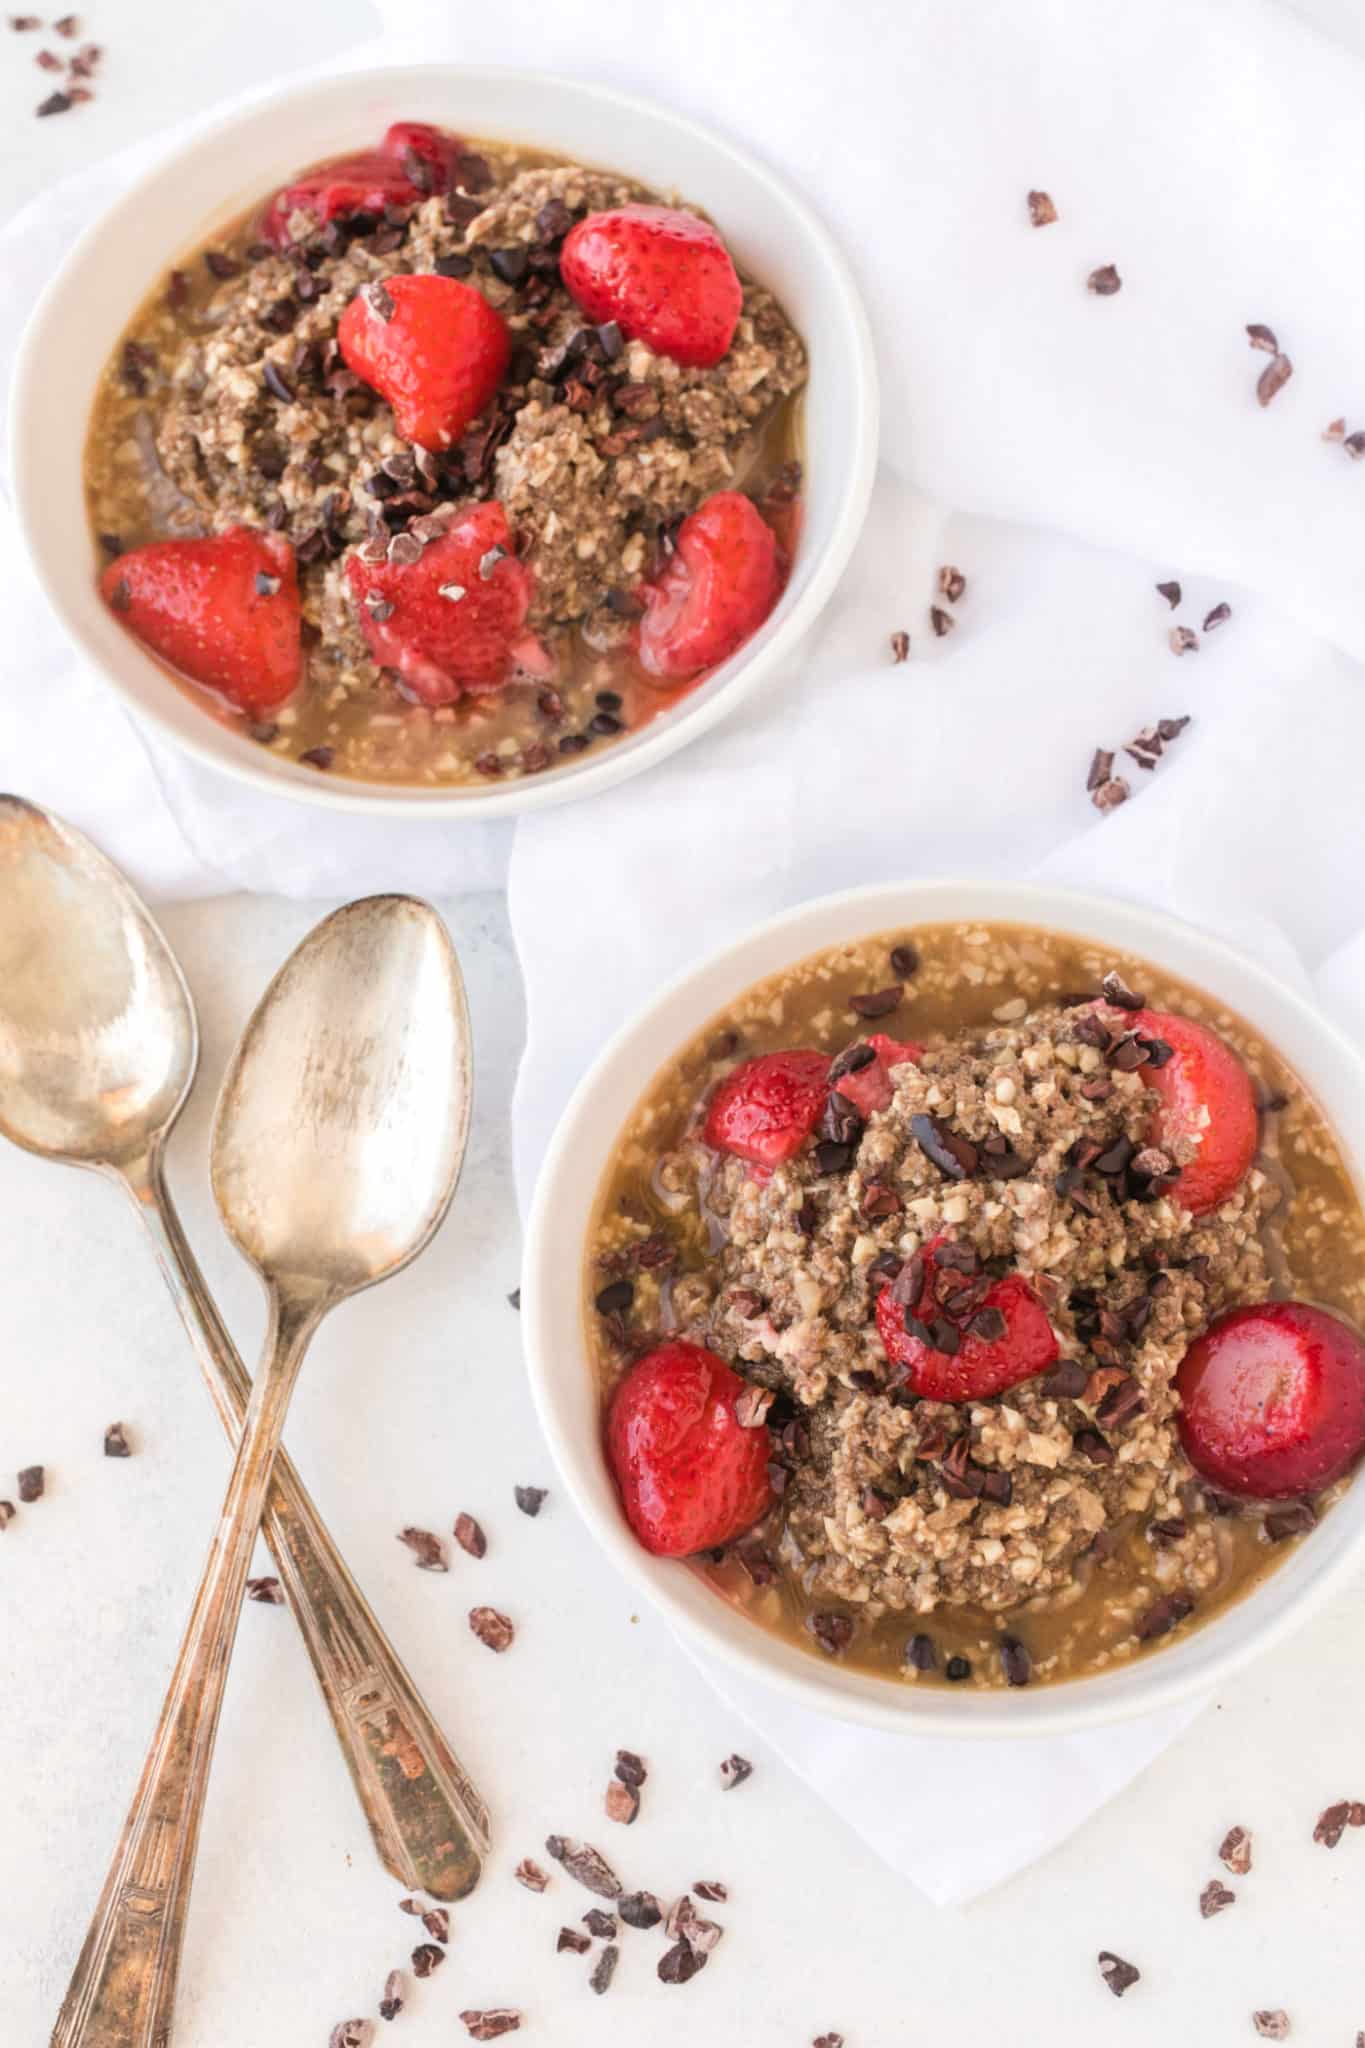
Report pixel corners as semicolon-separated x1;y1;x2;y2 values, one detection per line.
587;926;1365;1686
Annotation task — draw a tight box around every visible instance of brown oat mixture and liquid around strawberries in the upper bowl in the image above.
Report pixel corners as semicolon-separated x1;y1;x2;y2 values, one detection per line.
86;131;806;786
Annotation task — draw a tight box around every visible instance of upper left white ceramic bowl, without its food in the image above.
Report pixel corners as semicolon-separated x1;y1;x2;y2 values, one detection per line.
10;66;878;817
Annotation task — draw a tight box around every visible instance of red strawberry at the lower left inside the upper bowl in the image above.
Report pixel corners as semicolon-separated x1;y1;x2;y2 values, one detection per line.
100;526;303;715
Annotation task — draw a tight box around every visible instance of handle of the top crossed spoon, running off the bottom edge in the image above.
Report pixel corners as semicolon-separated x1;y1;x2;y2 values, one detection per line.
51;1296;323;2048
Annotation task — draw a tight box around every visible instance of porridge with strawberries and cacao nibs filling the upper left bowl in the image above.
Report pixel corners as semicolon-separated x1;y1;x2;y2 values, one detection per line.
86;121;806;788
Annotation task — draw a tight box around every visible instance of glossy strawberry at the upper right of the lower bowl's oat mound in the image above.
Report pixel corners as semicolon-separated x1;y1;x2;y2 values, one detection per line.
1126;1010;1261;1214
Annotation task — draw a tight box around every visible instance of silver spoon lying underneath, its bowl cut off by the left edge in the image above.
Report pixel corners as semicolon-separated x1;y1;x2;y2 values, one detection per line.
0;797;489;1898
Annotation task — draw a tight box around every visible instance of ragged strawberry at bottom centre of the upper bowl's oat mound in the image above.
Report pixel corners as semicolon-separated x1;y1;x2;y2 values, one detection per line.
346;498;532;705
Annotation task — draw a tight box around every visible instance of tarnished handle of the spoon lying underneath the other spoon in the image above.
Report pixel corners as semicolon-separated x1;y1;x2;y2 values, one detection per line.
127;1155;489;1898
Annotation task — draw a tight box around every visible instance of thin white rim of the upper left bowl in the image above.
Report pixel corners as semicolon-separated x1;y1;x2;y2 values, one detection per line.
8;63;880;819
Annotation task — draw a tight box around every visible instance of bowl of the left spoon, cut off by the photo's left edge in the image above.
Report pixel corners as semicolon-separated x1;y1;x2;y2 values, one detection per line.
0;795;199;1167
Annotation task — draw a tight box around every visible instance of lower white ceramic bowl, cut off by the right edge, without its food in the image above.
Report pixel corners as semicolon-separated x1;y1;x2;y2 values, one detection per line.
522;881;1365;1735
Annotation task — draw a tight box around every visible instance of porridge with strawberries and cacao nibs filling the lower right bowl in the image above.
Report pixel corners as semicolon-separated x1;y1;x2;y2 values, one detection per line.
585;924;1365;1688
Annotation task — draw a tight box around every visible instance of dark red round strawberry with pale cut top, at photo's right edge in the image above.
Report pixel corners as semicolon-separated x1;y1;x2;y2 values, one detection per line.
1175;1300;1365;1501
